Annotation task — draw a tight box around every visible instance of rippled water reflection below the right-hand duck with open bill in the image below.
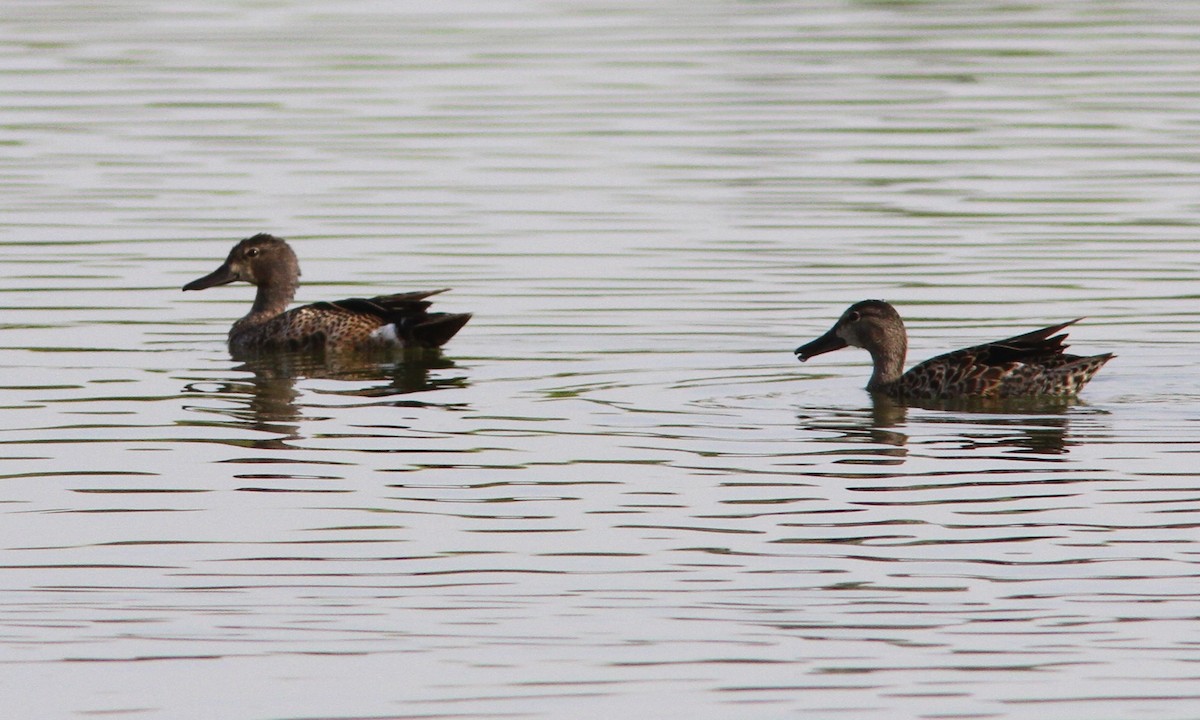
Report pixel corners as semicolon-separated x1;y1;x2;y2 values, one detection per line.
797;396;1080;464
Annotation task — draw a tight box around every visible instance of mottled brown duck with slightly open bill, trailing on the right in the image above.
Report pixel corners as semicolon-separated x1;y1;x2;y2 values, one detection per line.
796;300;1114;400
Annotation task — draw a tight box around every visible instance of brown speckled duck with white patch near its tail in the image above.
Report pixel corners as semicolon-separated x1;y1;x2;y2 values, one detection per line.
184;233;470;358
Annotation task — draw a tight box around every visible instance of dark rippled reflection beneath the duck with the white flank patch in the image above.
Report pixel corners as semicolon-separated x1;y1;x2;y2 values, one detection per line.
185;349;468;444
